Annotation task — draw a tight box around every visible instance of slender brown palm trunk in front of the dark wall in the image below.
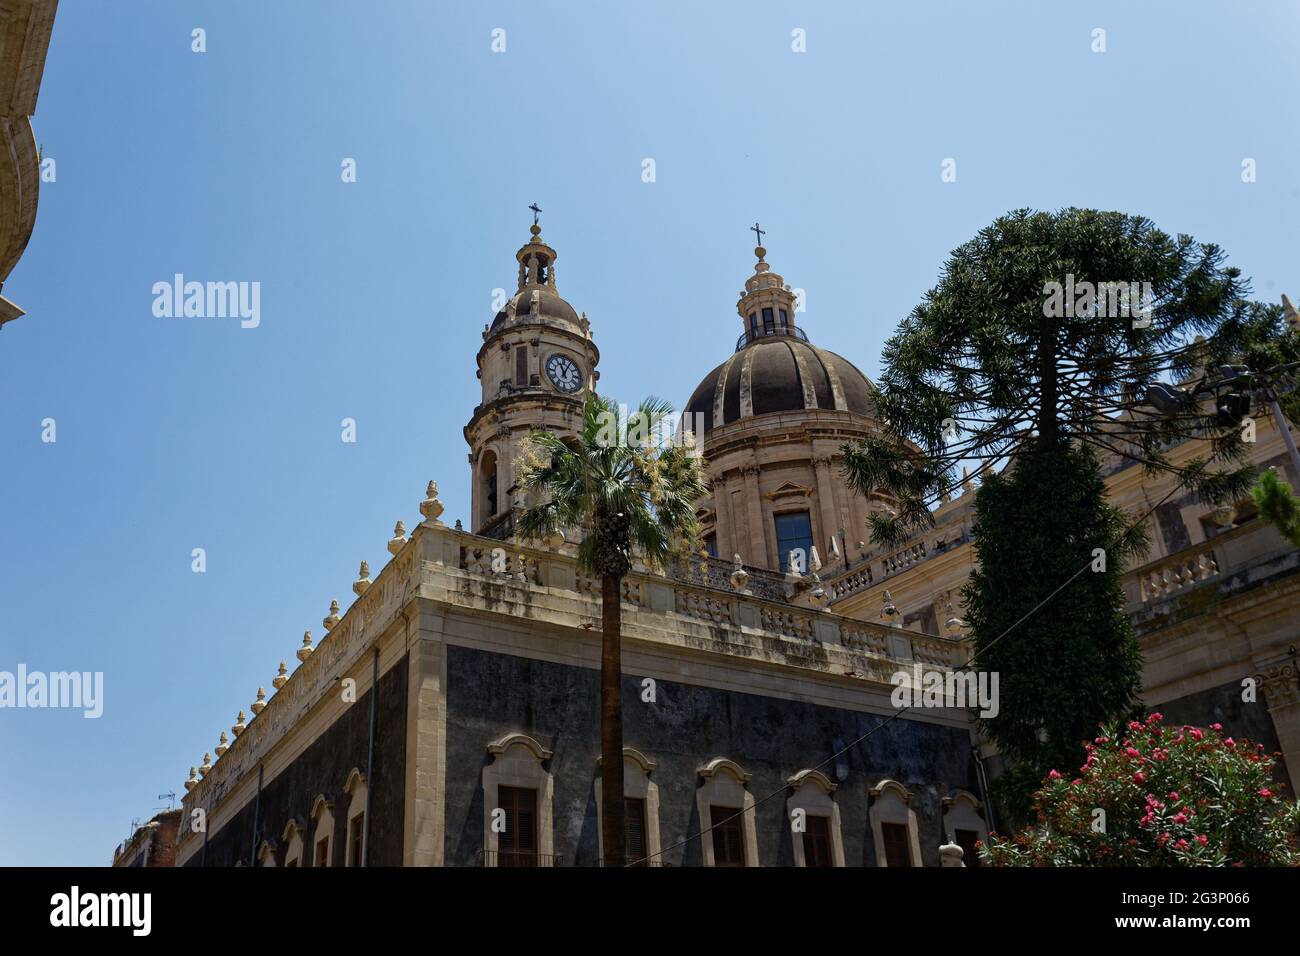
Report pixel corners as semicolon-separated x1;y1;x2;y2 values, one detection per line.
601;575;625;866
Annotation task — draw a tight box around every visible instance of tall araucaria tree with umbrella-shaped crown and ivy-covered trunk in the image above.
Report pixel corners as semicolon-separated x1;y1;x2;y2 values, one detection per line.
845;208;1278;809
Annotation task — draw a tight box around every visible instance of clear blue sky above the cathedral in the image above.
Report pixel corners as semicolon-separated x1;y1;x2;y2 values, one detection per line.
0;0;1300;865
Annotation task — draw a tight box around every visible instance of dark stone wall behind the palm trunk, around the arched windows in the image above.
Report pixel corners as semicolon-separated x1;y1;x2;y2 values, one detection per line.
446;646;978;866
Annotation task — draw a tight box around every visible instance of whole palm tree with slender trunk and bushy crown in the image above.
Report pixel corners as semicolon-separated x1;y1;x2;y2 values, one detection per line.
516;394;706;866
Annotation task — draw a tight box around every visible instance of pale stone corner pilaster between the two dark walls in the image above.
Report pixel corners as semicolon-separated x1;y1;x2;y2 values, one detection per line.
402;610;447;866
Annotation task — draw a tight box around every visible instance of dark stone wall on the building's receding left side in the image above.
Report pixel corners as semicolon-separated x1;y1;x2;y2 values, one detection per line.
186;657;407;866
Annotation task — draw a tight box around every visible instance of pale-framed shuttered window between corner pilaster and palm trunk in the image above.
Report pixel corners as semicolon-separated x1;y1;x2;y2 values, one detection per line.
484;734;555;866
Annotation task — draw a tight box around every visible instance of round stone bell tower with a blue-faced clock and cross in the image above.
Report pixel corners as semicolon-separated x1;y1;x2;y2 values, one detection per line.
465;215;601;537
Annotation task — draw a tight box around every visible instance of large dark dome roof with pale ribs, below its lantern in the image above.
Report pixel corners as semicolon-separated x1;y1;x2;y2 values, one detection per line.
686;334;875;434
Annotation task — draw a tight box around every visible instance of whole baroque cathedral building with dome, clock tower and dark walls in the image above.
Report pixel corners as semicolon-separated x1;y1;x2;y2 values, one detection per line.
177;219;1300;866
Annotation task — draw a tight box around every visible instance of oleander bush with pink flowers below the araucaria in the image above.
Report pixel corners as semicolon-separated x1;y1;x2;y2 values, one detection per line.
982;714;1300;866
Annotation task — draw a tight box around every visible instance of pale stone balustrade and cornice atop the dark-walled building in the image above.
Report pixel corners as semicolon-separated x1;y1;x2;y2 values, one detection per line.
185;522;965;809
